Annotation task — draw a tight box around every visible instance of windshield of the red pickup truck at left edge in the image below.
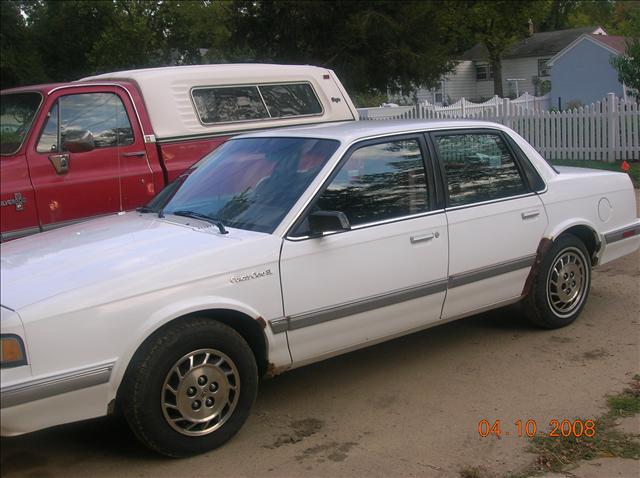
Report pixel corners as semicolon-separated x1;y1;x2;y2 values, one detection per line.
0;92;42;156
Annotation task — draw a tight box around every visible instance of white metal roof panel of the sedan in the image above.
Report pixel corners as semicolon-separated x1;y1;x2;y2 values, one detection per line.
236;119;505;143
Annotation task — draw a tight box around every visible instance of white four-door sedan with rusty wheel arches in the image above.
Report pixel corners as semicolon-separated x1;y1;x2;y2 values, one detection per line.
0;121;640;456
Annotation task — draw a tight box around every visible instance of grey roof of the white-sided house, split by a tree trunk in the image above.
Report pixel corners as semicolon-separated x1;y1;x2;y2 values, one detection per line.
462;27;600;61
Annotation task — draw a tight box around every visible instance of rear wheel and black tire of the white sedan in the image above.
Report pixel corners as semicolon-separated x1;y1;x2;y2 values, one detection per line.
523;233;591;329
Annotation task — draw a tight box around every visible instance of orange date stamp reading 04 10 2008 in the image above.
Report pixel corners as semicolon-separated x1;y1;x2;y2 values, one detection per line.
478;418;596;438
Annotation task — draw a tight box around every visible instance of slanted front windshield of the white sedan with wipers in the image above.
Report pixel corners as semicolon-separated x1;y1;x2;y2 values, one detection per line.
147;138;339;233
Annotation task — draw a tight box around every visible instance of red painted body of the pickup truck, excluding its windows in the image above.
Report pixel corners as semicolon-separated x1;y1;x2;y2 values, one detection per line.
0;81;230;240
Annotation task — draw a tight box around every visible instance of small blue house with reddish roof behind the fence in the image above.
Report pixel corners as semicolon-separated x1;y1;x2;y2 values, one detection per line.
547;33;626;109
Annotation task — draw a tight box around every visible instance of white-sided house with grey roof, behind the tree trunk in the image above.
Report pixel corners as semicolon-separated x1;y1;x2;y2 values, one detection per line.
408;27;607;104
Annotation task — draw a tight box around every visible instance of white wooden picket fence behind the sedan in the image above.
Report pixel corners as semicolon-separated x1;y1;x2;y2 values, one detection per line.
359;93;640;162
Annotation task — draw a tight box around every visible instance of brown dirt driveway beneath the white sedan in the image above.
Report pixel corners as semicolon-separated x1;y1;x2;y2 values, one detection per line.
1;197;640;478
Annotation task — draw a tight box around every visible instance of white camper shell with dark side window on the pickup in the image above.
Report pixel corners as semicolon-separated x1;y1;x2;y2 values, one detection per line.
80;64;358;141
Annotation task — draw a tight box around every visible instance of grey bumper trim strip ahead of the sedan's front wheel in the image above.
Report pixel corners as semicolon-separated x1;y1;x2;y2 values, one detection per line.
0;362;115;408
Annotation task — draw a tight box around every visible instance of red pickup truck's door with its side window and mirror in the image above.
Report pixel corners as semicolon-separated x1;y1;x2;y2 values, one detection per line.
27;87;151;229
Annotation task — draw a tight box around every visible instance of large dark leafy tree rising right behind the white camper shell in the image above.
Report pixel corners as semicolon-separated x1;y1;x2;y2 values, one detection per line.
229;0;460;93
